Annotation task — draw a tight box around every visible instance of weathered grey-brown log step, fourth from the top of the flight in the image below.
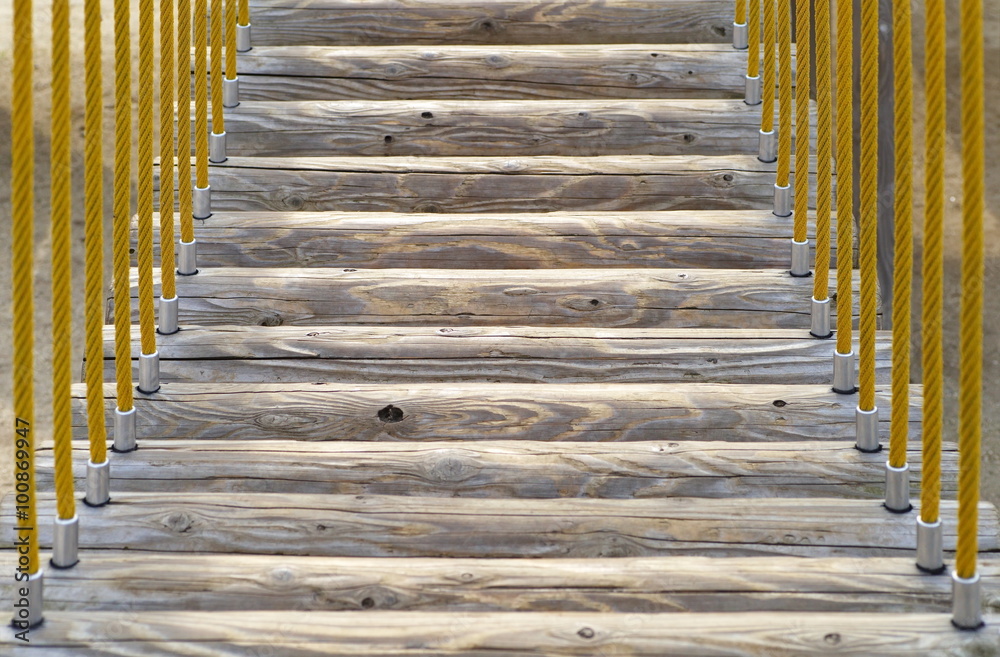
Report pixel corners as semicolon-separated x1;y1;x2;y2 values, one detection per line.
156;155;815;212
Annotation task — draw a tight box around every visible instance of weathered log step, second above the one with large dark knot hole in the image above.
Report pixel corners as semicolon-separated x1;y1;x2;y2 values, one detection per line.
115;267;857;329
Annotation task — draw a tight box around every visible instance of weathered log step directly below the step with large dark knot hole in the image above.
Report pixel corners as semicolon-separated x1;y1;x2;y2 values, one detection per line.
36;440;957;499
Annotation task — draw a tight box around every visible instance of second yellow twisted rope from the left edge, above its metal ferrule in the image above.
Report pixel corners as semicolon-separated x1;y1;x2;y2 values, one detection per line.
50;0;76;520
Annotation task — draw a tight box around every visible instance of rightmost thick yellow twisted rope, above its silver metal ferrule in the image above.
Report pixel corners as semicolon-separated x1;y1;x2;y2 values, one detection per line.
955;0;984;579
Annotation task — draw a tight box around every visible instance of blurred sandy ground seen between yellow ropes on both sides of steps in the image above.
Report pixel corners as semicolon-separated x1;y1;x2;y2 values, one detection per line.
0;0;1000;504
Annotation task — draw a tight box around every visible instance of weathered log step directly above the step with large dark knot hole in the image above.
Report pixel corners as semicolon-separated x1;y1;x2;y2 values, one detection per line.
104;326;891;384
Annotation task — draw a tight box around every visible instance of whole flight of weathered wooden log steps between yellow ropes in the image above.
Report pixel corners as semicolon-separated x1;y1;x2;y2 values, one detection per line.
23;0;1000;657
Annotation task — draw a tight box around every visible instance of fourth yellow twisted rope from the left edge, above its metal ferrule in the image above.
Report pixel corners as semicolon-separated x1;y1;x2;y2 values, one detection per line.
113;0;133;412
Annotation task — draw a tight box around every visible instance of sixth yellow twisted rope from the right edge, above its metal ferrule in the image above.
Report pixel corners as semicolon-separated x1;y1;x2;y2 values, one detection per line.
812;2;833;301
